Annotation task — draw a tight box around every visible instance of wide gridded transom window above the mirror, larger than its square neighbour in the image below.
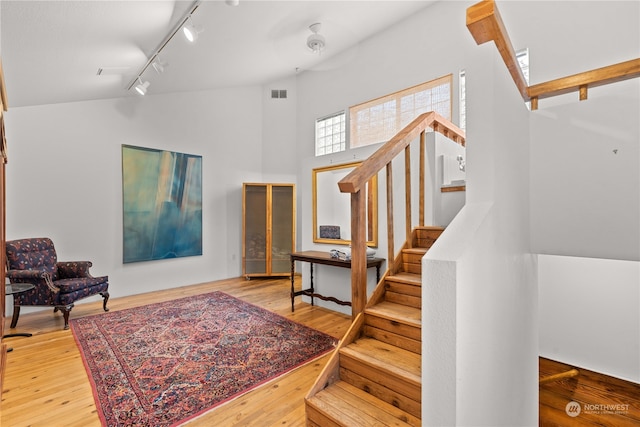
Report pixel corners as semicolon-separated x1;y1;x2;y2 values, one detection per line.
349;74;452;148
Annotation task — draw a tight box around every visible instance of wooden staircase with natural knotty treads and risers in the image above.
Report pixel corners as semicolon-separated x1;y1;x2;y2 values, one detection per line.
305;227;443;427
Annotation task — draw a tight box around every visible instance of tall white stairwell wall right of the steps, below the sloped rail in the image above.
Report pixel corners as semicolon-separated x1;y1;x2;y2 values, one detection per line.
457;45;538;426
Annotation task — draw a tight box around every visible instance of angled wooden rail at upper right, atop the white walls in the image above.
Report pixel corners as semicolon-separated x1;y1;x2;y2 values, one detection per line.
467;0;640;110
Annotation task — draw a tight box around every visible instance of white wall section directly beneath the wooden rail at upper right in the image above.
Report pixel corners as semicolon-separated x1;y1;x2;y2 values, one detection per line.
531;83;640;261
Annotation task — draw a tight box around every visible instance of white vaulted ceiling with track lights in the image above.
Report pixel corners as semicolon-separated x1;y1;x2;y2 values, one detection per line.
0;0;433;107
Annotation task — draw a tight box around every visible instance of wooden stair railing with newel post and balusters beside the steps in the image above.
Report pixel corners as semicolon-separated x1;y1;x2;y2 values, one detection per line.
338;111;465;319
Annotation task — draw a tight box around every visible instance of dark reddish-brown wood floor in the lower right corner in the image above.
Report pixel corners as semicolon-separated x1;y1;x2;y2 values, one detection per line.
539;357;640;427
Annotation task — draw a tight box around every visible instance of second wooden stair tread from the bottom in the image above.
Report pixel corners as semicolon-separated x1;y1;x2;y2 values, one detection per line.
340;337;422;387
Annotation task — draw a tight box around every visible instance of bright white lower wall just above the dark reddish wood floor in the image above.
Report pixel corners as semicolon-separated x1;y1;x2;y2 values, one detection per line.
538;255;640;383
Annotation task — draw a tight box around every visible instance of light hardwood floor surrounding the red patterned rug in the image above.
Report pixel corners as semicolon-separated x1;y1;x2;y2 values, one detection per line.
0;278;351;427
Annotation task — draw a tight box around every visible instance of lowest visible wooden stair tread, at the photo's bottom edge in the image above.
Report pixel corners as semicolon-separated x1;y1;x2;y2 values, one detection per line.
308;381;420;427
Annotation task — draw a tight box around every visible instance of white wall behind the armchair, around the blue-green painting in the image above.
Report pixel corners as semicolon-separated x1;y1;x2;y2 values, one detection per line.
6;87;276;307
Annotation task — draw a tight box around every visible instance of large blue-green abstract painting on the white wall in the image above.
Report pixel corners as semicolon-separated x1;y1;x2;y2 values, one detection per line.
122;145;202;263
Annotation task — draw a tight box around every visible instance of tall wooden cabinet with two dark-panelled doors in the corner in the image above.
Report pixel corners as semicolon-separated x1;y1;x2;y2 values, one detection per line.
242;183;296;279
